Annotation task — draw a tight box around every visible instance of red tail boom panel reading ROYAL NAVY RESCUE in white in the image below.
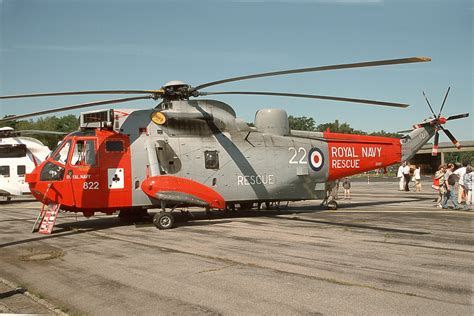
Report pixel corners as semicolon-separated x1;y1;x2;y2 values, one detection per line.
324;132;402;180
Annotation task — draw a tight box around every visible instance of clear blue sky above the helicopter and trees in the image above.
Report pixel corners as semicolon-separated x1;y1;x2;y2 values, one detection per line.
0;0;474;141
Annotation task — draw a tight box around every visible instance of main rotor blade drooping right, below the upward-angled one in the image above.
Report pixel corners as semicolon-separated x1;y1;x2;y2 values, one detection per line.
199;91;409;108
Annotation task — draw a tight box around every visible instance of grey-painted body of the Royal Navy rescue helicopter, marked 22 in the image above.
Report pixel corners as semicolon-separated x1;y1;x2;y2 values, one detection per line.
81;100;432;207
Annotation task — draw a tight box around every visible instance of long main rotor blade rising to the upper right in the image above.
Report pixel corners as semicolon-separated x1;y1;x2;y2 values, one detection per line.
194;57;431;90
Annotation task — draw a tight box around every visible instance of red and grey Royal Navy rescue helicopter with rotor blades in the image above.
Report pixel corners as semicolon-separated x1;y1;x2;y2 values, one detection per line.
0;57;466;229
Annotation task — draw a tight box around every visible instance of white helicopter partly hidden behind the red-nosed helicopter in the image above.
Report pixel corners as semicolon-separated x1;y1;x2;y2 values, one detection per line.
0;127;66;201
